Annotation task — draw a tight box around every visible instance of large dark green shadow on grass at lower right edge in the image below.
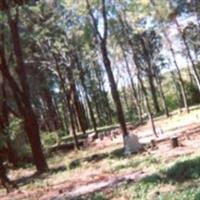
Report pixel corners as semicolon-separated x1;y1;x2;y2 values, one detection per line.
141;157;200;186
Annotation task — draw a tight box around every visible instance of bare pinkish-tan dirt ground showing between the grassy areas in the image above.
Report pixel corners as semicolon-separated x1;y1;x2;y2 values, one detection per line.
0;110;200;200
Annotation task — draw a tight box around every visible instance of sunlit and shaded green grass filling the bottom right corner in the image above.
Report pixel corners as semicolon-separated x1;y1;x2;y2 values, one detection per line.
86;156;200;200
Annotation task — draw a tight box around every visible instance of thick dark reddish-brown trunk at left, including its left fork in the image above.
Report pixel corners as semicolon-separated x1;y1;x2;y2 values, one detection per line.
1;14;48;172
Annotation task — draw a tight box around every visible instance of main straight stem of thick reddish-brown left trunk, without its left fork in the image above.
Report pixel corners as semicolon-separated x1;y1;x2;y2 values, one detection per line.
7;10;48;172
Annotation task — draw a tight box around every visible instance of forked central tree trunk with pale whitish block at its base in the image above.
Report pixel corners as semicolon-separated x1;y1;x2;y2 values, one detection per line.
86;0;141;153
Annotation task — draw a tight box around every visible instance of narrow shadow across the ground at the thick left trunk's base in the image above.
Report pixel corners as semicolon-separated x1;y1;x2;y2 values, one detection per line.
14;166;67;186
